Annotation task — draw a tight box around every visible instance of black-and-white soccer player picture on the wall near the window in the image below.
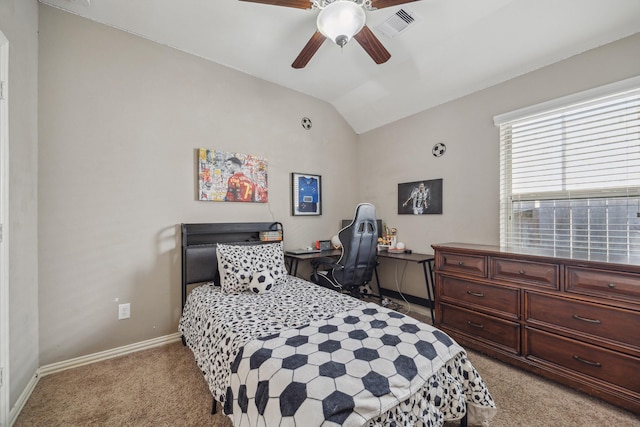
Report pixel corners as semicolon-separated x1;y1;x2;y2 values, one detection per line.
398;179;442;215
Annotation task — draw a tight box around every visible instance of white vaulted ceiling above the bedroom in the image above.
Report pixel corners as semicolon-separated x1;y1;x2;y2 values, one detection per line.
40;0;640;133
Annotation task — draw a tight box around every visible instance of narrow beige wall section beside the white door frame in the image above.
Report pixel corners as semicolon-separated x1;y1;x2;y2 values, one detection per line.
0;0;39;407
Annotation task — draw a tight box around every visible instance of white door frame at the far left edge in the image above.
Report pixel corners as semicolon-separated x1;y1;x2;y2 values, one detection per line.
0;31;11;427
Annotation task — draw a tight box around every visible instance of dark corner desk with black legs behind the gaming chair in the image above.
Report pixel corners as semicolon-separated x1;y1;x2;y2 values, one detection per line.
284;249;435;320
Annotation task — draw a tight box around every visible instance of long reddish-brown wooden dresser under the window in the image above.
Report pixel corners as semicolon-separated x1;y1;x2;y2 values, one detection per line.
433;243;640;413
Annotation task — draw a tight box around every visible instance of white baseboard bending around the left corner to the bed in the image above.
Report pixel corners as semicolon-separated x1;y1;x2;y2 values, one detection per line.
9;332;181;426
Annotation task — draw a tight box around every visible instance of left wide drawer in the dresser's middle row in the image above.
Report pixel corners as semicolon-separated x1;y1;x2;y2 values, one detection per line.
438;276;520;320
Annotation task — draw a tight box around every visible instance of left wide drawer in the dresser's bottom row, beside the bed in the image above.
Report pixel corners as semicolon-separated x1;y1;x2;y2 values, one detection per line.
439;304;520;353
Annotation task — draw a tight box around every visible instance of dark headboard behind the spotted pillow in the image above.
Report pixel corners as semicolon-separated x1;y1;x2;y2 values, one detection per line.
181;222;282;308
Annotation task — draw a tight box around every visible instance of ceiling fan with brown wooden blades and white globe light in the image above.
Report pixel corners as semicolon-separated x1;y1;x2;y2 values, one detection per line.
240;0;419;68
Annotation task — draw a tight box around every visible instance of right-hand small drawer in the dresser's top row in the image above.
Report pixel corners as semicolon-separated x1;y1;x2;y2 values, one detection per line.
566;266;640;302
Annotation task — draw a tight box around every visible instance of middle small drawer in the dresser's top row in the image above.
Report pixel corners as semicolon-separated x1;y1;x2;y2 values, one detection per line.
491;258;560;289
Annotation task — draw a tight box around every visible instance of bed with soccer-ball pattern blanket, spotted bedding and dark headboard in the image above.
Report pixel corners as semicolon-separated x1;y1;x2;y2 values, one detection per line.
179;223;496;427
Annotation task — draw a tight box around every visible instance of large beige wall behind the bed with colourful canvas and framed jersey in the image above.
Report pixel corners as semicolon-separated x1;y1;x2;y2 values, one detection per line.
38;5;356;365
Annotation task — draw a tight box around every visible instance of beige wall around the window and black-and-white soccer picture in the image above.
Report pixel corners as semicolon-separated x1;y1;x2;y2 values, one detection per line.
357;34;640;297
